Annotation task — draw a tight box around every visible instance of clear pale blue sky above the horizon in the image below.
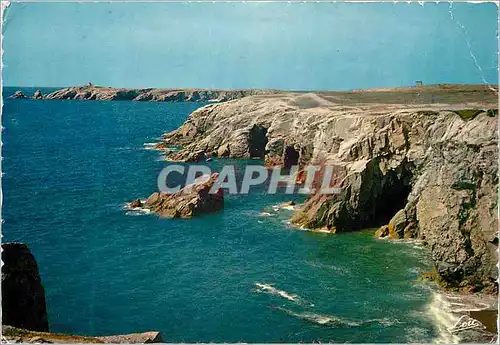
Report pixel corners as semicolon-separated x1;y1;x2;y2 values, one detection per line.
3;2;498;90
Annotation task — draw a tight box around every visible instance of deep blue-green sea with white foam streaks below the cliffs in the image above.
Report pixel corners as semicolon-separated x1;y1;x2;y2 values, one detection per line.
2;89;438;343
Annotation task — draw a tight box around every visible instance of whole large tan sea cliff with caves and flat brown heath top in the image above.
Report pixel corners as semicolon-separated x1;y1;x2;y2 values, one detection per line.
154;85;498;290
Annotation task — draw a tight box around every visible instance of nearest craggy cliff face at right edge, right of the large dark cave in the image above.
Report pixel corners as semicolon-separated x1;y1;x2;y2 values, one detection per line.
407;113;498;289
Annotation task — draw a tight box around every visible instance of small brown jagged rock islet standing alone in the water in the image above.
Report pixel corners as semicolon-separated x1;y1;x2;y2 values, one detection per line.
129;174;224;218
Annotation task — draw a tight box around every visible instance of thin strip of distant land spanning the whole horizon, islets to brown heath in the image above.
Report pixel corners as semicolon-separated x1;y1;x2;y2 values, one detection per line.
4;84;498;104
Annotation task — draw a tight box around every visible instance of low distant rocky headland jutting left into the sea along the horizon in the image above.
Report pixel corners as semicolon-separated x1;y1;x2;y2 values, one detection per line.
42;85;278;102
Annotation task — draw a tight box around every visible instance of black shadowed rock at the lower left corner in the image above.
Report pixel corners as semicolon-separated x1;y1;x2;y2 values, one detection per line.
2;243;49;332
